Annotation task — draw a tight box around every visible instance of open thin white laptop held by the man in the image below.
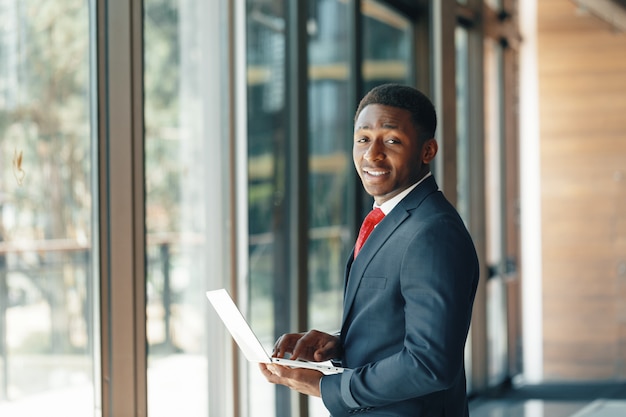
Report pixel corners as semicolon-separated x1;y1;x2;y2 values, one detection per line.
206;288;344;375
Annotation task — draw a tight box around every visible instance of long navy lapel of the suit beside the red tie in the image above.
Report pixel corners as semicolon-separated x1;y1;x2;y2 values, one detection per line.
342;176;437;323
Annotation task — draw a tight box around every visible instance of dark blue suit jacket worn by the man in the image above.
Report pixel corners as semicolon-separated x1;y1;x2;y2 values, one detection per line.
320;176;479;417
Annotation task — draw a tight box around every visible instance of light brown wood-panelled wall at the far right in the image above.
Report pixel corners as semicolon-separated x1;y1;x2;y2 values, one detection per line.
532;0;626;380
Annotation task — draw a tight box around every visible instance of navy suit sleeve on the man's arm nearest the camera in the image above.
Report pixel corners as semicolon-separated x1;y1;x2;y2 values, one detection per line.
320;215;478;416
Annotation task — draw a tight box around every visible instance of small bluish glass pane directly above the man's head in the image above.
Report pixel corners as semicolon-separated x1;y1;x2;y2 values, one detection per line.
361;0;415;94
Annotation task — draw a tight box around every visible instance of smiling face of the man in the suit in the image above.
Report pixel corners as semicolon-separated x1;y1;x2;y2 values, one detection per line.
352;104;436;204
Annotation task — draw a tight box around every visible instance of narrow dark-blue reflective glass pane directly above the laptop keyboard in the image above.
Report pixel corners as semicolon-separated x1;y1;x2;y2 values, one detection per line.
242;0;290;417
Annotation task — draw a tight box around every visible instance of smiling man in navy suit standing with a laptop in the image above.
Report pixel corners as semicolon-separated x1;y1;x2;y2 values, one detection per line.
260;84;479;417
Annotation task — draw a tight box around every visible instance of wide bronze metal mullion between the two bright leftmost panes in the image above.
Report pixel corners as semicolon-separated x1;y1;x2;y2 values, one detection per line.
97;0;147;417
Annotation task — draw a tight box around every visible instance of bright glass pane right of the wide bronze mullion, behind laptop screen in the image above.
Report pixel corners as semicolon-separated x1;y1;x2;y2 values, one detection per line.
144;0;232;417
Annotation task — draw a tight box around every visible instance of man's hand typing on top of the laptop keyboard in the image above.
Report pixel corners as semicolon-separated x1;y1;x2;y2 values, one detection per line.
272;330;341;362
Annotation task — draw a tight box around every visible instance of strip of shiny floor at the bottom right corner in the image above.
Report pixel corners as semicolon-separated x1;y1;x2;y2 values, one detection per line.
470;382;626;417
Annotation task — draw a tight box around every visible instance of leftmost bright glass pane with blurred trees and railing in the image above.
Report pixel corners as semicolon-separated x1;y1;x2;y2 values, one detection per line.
0;0;99;417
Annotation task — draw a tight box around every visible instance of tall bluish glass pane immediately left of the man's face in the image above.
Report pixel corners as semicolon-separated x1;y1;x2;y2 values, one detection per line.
308;0;354;417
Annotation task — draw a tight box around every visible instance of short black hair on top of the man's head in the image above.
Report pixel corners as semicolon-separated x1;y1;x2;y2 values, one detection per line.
354;84;437;140
